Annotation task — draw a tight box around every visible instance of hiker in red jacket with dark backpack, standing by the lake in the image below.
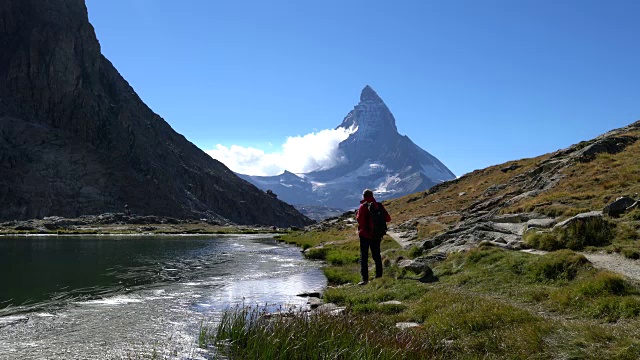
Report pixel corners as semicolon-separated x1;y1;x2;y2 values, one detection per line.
356;189;391;285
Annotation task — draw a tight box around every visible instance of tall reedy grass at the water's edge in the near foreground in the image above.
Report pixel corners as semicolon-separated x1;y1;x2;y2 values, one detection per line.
211;308;433;359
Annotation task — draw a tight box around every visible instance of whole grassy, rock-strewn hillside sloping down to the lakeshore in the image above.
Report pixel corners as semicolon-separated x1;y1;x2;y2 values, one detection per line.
202;122;640;359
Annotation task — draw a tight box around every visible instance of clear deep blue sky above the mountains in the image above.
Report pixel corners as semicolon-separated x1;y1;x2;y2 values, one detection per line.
87;0;640;175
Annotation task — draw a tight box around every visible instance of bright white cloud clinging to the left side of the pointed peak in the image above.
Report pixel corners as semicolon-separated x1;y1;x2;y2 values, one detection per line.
206;128;355;176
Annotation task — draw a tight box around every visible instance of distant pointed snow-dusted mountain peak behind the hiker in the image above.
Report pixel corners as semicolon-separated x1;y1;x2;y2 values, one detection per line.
240;85;455;209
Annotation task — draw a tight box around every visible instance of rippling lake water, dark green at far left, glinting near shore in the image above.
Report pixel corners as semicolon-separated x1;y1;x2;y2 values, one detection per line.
0;235;326;360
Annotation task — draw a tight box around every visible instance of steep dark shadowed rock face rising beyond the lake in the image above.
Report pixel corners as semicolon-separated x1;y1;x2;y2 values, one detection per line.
0;0;310;226
